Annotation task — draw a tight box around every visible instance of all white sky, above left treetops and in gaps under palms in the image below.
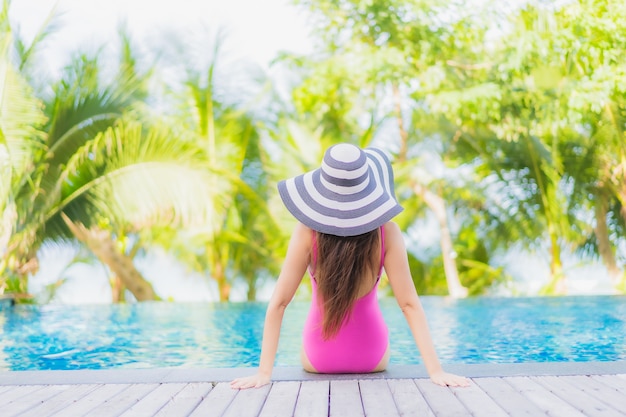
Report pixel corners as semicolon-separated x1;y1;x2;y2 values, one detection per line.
9;0;311;303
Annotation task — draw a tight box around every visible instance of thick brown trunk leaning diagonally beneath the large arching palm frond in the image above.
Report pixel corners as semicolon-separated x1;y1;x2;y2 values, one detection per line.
61;213;159;301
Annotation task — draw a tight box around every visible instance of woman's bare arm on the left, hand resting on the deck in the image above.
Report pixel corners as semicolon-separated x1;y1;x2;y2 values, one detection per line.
230;223;312;389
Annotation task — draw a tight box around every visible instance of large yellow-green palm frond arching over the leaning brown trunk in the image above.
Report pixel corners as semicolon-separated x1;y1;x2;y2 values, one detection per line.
44;122;227;237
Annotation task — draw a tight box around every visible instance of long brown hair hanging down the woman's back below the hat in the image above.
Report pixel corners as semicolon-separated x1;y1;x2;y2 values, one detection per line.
311;229;380;339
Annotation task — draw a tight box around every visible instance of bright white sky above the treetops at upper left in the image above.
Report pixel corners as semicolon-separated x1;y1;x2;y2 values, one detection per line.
10;0;311;73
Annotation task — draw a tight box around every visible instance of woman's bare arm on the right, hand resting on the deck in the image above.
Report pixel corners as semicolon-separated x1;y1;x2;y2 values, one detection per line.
385;222;469;386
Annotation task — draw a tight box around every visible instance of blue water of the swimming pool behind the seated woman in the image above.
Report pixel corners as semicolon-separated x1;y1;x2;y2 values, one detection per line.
0;296;626;371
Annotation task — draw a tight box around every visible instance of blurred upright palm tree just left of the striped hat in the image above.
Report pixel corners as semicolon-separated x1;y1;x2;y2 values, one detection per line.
152;32;278;301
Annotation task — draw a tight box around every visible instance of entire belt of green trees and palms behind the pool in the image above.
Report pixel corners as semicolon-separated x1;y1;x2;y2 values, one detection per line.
0;0;626;299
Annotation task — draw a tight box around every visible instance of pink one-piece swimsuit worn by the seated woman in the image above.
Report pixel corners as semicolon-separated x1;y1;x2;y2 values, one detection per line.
303;227;389;373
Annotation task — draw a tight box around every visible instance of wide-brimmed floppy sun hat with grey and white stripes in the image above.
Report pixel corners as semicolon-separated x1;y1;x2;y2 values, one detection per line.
278;143;403;236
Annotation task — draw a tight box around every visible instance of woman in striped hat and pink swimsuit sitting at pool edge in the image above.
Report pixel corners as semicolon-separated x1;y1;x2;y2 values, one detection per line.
231;144;469;389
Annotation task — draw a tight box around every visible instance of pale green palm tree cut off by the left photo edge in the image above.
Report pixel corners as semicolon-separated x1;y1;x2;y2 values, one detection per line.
0;8;46;294
